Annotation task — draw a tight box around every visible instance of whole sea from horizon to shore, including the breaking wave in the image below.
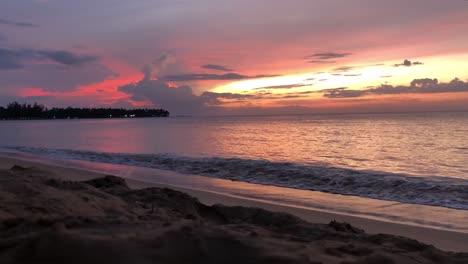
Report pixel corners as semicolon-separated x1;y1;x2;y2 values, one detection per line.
0;112;468;210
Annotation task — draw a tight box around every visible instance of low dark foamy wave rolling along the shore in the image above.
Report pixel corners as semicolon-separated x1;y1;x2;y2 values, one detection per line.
9;147;468;210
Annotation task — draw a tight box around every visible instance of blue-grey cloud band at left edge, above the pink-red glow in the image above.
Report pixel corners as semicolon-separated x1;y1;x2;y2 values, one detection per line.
0;48;98;70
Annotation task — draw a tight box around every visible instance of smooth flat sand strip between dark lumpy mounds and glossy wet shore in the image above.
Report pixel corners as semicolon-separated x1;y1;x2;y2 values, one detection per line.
0;156;468;252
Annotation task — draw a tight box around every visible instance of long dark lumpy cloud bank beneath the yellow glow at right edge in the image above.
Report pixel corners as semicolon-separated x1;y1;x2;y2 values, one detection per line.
324;78;468;98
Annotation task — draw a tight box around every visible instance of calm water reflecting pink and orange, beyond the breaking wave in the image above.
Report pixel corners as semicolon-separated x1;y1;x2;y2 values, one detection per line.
0;113;468;178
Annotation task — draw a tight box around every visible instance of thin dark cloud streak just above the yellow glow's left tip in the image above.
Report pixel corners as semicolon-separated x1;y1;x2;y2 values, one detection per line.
163;73;280;82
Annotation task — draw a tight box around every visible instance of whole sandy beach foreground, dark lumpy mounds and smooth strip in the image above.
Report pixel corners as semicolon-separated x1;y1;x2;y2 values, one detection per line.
0;158;468;264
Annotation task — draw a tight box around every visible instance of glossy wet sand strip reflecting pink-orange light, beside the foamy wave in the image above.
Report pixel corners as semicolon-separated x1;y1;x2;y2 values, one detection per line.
0;148;468;234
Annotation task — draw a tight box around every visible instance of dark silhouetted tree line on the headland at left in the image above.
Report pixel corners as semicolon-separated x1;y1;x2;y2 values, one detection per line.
0;102;169;120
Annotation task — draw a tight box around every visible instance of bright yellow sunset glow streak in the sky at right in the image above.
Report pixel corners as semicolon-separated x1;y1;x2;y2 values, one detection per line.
212;54;468;97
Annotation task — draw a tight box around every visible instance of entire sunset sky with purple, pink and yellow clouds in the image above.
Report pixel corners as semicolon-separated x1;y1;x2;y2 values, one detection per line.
0;0;468;115
